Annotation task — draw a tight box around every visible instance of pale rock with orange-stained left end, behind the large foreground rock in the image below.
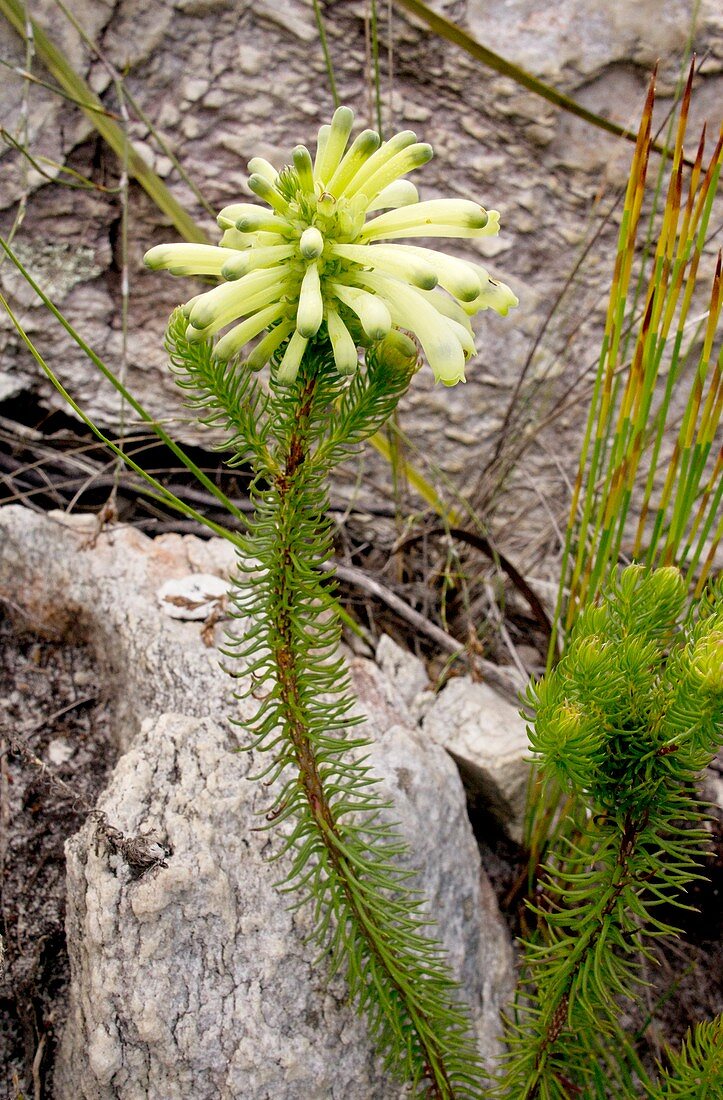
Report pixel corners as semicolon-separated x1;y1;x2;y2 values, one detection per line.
0;506;235;750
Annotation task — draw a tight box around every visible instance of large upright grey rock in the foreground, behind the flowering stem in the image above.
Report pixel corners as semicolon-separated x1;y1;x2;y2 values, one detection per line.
55;699;510;1100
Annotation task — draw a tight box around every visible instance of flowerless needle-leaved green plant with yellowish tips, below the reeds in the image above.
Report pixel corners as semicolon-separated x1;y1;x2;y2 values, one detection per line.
500;565;723;1100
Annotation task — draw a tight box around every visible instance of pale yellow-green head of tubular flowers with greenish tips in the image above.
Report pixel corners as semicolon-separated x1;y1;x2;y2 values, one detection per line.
144;107;517;385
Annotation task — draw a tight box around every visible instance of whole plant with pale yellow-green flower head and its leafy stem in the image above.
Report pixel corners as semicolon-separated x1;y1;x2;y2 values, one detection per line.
138;107;517;1100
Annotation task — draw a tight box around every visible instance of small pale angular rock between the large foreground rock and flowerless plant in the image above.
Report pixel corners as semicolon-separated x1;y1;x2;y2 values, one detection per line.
423;677;529;840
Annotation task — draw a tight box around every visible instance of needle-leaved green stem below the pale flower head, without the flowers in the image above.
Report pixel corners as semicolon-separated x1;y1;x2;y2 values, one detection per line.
167;314;482;1100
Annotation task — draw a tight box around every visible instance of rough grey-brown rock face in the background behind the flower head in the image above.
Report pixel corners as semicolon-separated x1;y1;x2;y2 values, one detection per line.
0;0;723;565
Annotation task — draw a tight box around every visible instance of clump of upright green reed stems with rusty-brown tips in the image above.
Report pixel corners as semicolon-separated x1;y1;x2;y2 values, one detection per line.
550;67;723;660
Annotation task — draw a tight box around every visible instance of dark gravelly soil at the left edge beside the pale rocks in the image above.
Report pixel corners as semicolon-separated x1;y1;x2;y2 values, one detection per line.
0;620;114;1100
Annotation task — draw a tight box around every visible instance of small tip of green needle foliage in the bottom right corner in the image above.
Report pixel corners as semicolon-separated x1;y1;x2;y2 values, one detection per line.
648;1016;723;1100
